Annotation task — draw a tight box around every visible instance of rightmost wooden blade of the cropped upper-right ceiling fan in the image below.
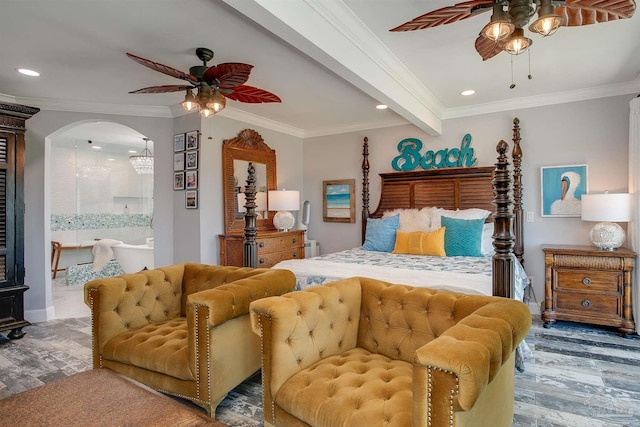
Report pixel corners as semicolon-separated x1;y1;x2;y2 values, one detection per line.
556;0;636;27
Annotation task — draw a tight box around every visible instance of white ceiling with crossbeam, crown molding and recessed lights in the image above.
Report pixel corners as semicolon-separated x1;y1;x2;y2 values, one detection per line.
0;0;640;137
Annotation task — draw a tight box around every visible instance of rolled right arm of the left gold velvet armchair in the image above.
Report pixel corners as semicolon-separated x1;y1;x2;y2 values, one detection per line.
187;269;296;326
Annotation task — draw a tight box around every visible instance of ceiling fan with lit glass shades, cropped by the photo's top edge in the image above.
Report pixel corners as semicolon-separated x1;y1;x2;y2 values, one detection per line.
389;0;636;61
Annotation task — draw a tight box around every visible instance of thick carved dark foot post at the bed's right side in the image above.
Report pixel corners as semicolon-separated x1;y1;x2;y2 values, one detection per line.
492;141;515;298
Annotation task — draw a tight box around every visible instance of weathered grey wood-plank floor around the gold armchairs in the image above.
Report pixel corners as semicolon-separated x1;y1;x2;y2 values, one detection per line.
0;317;640;427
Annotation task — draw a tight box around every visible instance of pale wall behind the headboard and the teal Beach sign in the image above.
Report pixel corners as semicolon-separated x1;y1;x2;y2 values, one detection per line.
303;96;632;308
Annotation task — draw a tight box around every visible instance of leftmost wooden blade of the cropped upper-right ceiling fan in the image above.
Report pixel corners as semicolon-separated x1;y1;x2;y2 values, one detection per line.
389;0;495;31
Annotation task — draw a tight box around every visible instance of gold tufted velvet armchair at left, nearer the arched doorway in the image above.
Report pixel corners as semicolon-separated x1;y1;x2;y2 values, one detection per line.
84;263;295;417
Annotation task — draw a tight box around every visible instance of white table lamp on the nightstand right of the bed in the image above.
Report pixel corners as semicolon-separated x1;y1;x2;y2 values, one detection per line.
581;193;631;251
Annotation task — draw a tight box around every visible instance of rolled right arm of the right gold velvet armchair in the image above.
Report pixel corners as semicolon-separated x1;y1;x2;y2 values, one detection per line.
414;299;531;411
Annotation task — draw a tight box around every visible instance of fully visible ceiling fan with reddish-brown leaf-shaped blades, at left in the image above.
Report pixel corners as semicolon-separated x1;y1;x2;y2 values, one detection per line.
127;47;281;117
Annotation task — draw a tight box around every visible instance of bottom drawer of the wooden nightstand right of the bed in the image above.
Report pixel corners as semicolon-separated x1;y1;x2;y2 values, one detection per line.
556;291;622;318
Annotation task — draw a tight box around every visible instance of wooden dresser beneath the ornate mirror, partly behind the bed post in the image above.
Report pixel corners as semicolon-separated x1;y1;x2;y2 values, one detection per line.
220;230;304;268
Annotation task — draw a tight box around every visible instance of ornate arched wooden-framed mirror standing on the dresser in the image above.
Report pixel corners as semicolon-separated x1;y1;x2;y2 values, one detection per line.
222;129;277;234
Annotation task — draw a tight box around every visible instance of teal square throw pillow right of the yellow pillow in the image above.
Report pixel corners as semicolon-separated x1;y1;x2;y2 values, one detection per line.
441;216;484;256
